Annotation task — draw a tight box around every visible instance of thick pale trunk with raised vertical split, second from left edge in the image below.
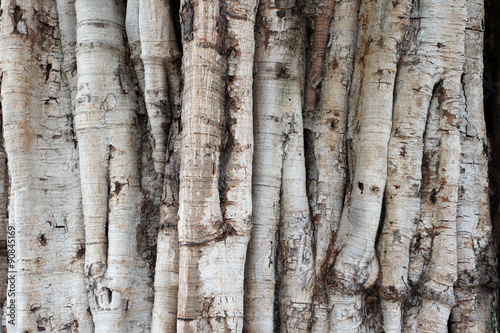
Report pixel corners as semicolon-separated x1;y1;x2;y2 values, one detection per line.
75;0;152;332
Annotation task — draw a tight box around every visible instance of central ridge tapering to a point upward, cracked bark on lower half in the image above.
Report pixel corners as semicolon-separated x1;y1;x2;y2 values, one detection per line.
278;105;315;332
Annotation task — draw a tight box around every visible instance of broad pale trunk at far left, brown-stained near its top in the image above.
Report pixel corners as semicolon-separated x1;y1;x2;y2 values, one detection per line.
0;0;92;332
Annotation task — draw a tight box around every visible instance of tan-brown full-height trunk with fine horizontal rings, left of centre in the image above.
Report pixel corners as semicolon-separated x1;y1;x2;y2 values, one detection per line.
177;0;227;332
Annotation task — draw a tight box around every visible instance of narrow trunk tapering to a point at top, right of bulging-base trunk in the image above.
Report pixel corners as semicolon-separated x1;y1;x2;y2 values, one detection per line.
378;1;441;332
